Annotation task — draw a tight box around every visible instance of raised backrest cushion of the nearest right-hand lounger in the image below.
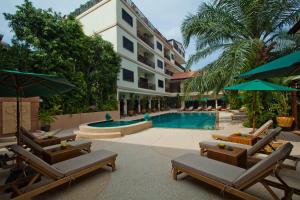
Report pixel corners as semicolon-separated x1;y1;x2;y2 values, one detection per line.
234;143;293;189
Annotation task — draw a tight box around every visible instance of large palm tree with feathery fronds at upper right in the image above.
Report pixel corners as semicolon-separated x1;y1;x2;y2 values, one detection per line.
181;0;300;93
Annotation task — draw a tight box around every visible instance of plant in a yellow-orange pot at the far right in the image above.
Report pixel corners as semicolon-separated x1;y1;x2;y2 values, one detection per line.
274;95;295;128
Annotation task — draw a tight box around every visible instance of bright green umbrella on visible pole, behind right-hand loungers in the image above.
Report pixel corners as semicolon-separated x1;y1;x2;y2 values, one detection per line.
224;80;297;131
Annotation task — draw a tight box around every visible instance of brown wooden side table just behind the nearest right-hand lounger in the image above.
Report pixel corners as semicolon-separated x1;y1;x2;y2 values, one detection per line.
207;146;247;168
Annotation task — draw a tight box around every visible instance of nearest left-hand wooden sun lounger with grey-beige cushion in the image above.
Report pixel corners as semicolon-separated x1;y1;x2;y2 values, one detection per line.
1;145;117;199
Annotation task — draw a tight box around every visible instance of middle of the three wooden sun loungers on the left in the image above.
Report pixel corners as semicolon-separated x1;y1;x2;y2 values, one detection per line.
22;135;92;164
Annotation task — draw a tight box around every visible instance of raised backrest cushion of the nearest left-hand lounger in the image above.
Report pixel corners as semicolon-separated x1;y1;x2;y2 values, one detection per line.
9;145;64;179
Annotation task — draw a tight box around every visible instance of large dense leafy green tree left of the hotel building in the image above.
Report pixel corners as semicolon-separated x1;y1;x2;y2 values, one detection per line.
0;0;121;113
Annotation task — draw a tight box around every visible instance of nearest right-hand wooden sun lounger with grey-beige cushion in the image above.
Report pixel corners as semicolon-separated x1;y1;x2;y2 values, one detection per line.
171;143;300;200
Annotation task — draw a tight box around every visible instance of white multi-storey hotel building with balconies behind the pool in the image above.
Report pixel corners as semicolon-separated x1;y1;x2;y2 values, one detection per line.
74;0;185;115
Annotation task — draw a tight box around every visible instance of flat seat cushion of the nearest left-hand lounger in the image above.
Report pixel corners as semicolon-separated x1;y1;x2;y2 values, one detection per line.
52;150;117;176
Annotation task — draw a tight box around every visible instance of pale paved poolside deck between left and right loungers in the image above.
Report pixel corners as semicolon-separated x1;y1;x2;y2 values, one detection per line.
0;112;300;200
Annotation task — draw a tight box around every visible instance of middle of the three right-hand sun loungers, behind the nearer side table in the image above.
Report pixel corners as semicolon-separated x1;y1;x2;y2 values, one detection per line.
199;127;300;170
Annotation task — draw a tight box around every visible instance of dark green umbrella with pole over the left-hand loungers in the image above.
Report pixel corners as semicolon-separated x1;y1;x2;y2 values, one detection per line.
0;70;74;144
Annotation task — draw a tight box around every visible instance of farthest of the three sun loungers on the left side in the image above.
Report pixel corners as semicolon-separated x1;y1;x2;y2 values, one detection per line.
21;127;76;147
